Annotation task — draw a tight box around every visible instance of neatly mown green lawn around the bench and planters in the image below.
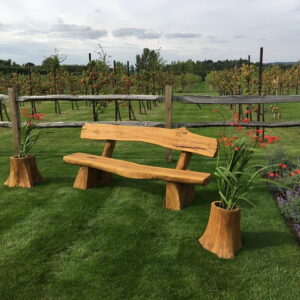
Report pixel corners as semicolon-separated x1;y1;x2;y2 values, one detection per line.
0;92;300;300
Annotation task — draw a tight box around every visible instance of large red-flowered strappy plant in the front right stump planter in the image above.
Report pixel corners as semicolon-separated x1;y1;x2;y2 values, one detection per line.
214;111;279;210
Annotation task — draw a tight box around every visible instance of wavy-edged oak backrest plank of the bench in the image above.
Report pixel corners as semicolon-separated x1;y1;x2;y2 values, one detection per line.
80;123;218;157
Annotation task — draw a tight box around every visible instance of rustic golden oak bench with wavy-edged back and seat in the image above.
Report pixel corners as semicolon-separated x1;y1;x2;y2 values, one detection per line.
63;123;218;210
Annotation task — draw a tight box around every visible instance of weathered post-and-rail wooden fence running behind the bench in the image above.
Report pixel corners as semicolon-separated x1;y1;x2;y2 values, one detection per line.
0;86;300;156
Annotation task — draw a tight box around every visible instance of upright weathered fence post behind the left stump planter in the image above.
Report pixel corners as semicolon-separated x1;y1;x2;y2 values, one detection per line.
8;88;21;155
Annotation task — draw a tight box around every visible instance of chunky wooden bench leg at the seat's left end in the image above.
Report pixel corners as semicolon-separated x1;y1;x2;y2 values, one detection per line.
73;167;112;190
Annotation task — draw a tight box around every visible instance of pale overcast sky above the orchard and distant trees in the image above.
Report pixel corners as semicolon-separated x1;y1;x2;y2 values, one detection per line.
0;0;300;64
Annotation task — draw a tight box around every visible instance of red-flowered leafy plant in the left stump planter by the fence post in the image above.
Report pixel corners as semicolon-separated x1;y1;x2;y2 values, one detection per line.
18;108;45;157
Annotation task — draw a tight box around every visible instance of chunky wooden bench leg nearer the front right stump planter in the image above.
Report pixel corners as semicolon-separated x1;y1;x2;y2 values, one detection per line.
163;182;195;210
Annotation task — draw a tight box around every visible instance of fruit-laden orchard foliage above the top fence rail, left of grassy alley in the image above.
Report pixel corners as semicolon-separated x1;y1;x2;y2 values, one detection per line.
0;68;174;95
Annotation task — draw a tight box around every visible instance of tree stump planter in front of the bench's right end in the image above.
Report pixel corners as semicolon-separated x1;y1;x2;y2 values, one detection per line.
199;201;242;259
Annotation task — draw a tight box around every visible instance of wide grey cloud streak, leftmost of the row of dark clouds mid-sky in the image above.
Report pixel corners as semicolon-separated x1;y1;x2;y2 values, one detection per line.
51;22;107;39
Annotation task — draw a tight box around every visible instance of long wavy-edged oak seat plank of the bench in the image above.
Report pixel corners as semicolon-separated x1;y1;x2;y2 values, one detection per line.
63;153;211;185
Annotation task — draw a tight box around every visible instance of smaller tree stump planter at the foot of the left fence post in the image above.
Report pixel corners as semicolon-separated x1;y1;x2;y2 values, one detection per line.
4;155;44;188
